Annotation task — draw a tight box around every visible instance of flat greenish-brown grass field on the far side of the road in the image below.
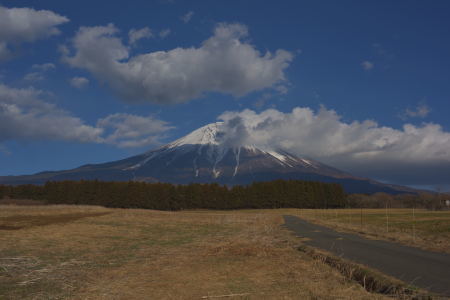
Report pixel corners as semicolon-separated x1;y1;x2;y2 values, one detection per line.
290;208;450;253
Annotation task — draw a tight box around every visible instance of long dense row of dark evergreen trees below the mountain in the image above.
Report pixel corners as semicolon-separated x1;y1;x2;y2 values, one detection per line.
0;180;346;210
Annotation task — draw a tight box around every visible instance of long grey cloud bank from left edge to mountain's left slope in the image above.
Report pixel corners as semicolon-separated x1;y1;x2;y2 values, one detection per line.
0;84;172;147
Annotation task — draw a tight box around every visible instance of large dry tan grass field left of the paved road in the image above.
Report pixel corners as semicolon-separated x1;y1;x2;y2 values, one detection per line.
0;205;390;299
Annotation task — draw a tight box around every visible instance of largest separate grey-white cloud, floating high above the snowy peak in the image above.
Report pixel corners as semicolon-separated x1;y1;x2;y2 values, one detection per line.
63;24;293;103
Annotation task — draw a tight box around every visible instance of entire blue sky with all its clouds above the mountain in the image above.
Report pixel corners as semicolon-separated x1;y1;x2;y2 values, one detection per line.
0;0;450;188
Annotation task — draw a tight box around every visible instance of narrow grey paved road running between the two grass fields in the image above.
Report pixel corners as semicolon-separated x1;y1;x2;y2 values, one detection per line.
284;216;450;296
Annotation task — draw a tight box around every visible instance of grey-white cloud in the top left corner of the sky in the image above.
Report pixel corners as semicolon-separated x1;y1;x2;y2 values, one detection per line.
0;6;69;60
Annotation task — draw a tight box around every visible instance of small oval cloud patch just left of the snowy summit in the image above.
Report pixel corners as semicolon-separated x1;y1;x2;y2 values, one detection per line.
97;113;173;148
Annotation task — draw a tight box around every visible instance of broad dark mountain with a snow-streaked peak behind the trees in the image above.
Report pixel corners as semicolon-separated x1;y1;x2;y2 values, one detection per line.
0;122;414;194
